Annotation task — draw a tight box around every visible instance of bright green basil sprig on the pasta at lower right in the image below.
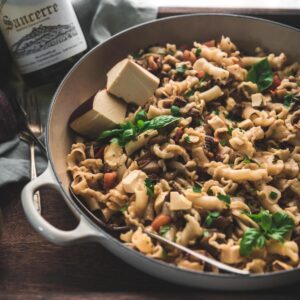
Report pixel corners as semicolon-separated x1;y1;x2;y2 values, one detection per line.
240;210;295;256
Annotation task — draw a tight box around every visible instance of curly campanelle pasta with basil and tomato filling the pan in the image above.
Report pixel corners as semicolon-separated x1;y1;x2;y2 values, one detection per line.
67;36;300;273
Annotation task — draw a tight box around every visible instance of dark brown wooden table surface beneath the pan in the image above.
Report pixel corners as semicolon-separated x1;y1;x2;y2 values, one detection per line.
0;8;300;300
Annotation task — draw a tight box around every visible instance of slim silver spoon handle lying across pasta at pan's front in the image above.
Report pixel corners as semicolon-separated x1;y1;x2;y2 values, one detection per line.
144;230;250;275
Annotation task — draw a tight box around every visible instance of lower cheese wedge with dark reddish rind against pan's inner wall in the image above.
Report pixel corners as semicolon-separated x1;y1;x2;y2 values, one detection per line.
69;90;126;139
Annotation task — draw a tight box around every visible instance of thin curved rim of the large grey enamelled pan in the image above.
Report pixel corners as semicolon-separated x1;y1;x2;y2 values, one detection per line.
45;13;300;281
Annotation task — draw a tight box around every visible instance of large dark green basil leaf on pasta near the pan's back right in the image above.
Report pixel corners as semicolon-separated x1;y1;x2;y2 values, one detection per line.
247;58;273;92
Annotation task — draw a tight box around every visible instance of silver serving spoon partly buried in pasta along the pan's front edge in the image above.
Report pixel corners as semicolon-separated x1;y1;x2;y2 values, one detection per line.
69;186;250;275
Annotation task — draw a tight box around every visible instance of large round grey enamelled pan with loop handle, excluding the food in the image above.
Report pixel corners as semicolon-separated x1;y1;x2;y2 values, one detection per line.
22;14;300;291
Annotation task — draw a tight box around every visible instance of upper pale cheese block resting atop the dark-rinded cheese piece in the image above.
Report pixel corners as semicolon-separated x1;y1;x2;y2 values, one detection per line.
107;58;159;105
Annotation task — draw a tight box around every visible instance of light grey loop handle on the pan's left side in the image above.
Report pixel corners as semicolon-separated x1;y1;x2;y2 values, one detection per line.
21;164;105;245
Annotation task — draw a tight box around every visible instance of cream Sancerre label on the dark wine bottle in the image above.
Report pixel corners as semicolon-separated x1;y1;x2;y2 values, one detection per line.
0;0;87;74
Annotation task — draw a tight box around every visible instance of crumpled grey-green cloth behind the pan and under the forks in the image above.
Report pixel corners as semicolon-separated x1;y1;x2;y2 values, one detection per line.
0;0;157;187
